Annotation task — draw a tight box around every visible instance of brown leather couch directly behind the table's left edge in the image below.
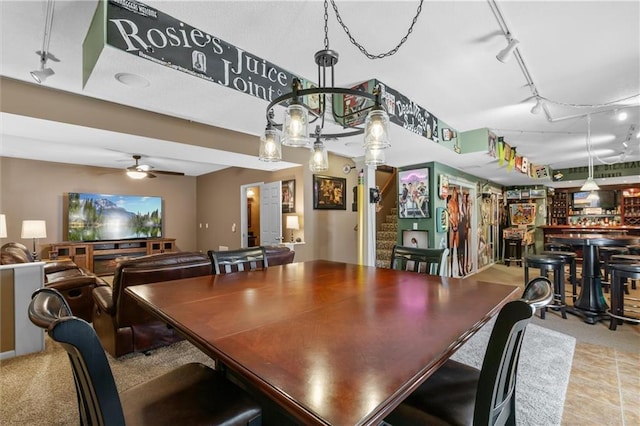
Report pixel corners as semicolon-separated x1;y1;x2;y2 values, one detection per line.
93;252;212;357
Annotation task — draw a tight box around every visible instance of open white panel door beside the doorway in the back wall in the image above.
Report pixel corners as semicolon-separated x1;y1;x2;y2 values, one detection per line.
260;181;282;246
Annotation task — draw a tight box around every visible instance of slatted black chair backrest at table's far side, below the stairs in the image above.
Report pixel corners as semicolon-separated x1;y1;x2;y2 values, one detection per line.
391;245;449;276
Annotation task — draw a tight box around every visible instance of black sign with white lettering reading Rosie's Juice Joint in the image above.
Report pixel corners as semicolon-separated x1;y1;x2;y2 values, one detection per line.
106;0;313;102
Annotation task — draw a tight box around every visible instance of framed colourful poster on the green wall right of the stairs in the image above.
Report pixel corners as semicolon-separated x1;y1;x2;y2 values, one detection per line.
398;168;431;219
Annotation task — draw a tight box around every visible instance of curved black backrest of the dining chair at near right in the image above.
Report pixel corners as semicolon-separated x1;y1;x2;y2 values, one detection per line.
473;300;533;425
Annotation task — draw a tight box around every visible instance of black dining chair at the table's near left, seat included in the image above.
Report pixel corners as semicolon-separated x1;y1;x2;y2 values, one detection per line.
28;288;262;425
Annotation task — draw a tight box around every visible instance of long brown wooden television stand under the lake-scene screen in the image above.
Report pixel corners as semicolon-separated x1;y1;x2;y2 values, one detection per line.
51;238;176;275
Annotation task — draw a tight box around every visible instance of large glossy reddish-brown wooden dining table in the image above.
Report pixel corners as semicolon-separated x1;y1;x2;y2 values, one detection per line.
126;260;521;425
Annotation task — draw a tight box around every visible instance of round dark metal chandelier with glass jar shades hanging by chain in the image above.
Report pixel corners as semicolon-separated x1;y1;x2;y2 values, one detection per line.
259;0;422;172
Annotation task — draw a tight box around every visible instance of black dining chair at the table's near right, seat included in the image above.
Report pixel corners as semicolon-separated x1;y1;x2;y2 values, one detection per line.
385;279;553;426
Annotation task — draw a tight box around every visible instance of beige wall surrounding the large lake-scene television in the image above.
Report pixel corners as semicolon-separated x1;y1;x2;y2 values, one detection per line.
0;157;196;258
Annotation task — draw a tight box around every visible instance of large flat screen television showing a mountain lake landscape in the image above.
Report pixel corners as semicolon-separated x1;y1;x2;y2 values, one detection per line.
66;192;162;241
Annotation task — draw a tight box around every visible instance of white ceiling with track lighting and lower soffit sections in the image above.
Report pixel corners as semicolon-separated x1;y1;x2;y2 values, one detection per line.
1;0;640;187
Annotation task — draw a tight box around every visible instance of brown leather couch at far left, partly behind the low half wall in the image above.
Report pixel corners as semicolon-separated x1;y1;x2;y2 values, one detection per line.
0;242;108;322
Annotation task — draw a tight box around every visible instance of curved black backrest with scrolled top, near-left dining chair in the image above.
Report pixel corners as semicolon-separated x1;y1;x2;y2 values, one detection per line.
29;288;125;425
